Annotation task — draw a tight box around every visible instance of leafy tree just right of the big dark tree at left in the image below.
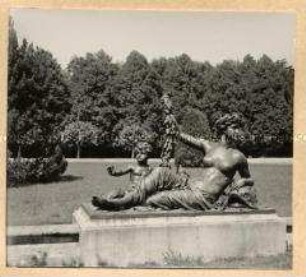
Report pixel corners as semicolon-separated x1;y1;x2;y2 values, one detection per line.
67;50;118;143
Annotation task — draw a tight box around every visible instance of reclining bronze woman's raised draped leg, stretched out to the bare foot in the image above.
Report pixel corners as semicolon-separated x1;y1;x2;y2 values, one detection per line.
92;167;179;210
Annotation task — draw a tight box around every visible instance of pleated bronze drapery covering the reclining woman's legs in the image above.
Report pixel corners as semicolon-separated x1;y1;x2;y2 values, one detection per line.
99;167;215;210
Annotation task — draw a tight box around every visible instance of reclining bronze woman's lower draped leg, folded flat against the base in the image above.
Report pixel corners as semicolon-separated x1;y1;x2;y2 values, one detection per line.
146;189;212;210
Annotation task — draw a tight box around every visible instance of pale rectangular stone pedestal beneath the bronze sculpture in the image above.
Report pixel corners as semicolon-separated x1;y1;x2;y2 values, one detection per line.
74;205;286;267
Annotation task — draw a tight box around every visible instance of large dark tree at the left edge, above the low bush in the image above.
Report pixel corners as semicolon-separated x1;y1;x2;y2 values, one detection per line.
8;21;70;156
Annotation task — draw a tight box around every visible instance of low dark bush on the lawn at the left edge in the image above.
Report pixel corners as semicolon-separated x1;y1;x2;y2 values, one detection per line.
7;148;68;187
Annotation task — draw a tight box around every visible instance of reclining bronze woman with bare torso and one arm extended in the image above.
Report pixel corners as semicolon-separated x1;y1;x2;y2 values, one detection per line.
92;114;256;210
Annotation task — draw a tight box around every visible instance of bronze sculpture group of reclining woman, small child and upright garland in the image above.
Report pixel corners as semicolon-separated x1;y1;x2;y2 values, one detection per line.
92;94;257;211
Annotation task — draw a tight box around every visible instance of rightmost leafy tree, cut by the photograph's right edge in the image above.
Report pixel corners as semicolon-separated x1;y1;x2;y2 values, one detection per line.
247;55;293;155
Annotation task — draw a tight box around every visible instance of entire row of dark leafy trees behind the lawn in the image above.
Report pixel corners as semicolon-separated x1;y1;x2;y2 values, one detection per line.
8;22;294;157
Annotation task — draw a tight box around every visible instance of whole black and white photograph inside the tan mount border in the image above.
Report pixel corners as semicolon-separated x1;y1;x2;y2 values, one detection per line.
6;8;296;270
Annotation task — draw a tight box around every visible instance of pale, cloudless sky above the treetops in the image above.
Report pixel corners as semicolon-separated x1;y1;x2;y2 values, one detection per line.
11;9;296;67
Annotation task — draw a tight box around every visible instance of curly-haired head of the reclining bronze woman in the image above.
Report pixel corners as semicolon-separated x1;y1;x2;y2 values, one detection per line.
215;113;246;147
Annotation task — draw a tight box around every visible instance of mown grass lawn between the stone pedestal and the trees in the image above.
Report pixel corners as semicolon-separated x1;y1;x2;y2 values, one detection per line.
7;161;292;225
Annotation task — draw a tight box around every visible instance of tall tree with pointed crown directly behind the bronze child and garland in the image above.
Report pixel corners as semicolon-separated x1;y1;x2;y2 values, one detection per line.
110;51;163;153
